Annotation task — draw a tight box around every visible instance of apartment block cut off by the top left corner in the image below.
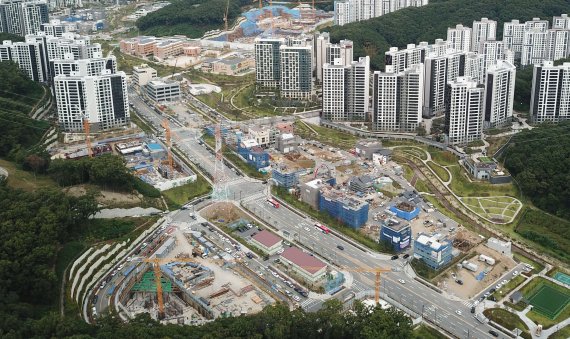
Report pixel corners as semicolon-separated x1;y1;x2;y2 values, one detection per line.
0;0;49;36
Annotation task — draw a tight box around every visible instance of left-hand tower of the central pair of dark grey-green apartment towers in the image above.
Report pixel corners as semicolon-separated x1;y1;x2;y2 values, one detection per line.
255;38;285;88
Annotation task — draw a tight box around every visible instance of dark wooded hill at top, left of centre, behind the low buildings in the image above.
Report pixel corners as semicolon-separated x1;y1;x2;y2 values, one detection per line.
136;0;252;38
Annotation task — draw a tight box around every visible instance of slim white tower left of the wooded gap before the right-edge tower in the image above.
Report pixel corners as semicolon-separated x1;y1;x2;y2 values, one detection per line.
484;61;516;128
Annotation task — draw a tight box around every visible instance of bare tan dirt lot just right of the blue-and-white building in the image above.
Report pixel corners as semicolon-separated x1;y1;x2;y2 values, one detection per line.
437;244;516;299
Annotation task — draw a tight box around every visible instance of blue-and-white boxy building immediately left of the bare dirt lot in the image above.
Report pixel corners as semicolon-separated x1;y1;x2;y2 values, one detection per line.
414;233;453;270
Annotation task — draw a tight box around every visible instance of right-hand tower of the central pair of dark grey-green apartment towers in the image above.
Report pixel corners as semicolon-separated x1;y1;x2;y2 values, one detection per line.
279;45;313;99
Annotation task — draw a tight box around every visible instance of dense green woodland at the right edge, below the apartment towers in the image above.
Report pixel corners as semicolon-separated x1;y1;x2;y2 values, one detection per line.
503;122;570;219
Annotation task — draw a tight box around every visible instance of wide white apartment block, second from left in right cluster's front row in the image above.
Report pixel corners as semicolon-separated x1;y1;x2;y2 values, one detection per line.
372;64;424;132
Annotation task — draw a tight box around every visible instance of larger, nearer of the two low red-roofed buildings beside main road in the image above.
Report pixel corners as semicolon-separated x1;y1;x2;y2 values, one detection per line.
281;247;327;284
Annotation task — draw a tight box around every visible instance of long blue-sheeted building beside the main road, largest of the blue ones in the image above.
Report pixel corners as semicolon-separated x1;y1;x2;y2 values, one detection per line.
319;187;369;228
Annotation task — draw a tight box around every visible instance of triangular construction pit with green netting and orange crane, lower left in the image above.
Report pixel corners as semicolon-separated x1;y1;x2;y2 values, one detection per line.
119;223;274;325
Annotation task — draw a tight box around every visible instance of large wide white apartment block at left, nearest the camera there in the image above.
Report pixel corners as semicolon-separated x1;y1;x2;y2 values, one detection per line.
54;71;130;131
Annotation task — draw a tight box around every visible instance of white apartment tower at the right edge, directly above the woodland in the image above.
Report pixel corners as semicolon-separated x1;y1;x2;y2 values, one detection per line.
530;61;570;123
